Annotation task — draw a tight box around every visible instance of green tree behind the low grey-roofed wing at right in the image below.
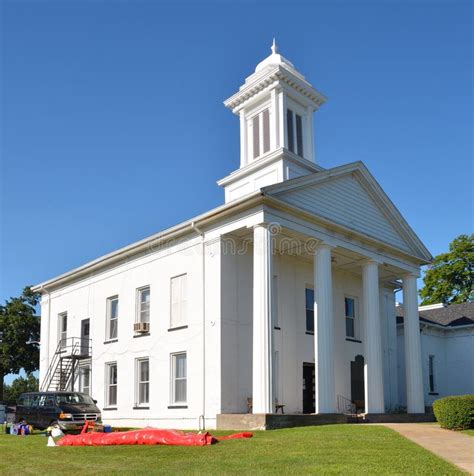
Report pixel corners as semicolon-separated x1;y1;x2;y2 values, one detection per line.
420;234;474;305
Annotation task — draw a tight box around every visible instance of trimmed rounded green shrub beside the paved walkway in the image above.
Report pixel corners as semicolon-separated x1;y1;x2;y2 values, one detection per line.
433;395;474;430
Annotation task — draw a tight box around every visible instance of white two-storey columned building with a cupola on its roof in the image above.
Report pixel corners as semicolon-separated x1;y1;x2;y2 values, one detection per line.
34;46;440;428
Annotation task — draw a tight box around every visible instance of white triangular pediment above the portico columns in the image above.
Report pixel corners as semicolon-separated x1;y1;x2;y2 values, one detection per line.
265;162;431;261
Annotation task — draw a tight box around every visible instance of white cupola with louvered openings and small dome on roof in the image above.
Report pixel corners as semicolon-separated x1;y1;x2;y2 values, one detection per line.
218;40;326;202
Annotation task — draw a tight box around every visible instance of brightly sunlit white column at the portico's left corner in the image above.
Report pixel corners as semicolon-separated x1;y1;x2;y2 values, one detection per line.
252;224;273;413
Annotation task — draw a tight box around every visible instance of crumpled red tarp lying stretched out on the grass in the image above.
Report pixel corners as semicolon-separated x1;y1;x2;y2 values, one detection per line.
56;428;253;446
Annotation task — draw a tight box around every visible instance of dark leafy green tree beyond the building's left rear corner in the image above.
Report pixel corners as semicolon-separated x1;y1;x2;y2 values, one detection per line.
0;287;40;402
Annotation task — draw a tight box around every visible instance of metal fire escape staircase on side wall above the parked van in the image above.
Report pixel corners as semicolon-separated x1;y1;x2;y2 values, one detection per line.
41;337;92;392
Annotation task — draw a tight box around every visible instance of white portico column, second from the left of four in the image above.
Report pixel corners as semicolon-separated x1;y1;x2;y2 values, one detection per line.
314;244;336;413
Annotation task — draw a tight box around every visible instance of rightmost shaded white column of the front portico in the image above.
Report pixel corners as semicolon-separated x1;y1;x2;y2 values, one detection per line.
403;274;425;413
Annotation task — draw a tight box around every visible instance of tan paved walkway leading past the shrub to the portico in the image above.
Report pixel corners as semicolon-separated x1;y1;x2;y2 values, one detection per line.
381;423;474;475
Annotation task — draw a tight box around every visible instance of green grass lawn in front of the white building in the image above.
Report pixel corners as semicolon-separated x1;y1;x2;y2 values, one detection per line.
0;425;462;475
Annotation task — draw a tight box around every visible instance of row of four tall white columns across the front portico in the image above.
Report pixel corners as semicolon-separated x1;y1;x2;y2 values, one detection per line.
252;224;424;413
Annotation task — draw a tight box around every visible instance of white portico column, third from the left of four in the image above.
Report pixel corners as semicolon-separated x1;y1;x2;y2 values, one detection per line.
362;261;385;413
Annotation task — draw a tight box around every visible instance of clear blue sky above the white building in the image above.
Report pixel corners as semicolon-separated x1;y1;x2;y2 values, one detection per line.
0;0;473;302
